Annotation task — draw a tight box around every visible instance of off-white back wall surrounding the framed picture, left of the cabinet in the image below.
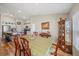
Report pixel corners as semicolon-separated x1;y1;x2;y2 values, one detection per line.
31;14;66;42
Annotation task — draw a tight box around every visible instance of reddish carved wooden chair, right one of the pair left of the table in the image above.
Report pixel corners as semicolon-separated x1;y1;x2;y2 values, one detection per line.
21;38;31;56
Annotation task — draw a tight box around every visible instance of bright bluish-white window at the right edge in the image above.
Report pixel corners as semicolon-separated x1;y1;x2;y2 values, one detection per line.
73;12;79;51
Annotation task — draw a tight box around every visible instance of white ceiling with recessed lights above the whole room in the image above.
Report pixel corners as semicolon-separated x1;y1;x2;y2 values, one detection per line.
0;3;74;19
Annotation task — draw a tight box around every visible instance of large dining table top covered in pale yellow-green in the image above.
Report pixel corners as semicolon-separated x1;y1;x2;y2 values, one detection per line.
23;35;52;56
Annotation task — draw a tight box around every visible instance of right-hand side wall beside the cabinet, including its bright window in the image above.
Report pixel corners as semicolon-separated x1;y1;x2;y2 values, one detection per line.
69;4;79;55
